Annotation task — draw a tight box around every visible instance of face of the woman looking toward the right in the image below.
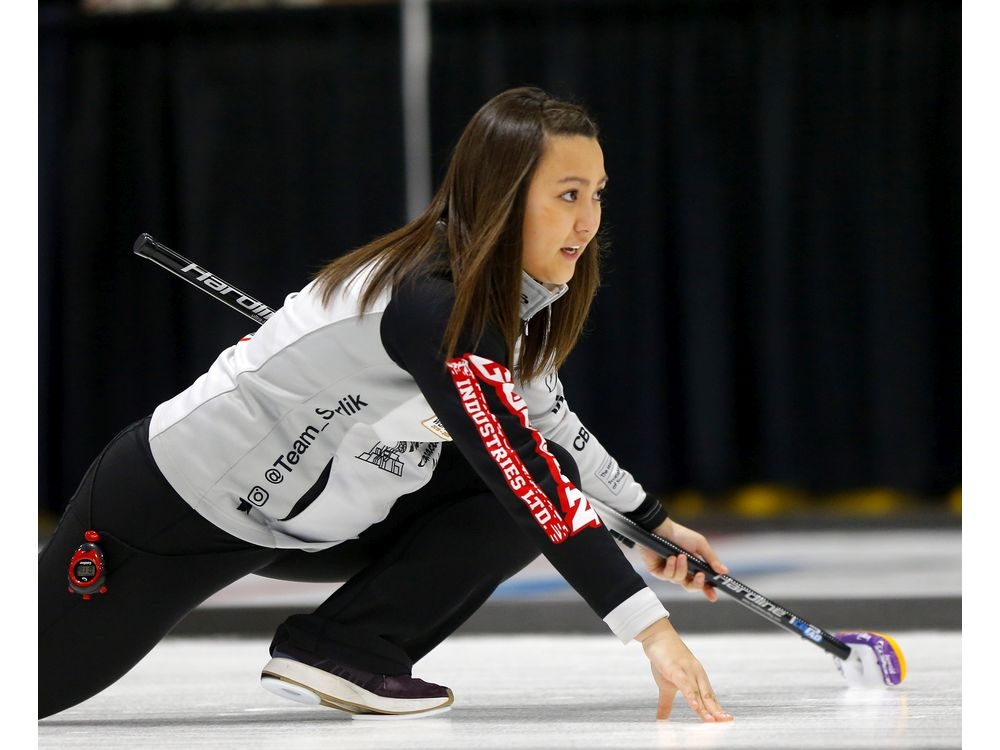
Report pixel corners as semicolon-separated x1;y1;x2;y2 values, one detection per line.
521;135;608;284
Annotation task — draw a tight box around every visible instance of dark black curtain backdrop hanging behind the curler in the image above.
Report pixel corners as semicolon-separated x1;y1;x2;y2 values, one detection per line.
39;0;961;511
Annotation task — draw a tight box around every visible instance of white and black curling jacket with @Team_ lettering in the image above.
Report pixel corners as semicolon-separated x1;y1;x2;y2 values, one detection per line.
150;267;666;642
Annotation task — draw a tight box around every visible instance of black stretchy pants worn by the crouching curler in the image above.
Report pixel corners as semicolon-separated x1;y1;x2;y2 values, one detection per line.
38;418;556;718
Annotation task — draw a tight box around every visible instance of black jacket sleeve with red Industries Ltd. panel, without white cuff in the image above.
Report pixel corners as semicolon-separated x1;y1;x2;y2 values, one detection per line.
381;278;645;618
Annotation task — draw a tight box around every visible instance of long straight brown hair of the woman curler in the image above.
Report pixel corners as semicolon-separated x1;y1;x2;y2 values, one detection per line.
316;87;600;380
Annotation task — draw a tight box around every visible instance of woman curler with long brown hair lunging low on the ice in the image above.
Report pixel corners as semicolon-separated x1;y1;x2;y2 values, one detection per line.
39;88;732;721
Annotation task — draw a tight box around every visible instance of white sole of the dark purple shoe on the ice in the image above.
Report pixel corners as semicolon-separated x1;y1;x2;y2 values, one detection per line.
260;657;455;718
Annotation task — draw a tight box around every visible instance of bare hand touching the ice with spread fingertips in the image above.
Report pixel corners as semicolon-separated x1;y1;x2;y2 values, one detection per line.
636;618;733;722
